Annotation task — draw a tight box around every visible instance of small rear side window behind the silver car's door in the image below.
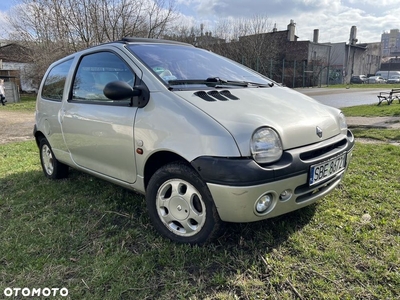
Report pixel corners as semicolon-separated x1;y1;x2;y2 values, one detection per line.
42;59;72;101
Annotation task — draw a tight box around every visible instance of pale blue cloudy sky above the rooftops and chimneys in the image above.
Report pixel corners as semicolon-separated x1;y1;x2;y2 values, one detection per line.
0;0;400;43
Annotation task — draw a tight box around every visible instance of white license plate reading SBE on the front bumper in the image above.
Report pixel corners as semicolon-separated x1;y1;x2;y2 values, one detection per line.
309;153;346;185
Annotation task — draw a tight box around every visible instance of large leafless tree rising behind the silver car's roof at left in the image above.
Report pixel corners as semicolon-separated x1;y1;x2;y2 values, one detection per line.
8;0;176;88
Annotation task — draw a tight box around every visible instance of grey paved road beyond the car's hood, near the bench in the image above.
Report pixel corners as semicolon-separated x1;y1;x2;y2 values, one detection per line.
296;86;390;108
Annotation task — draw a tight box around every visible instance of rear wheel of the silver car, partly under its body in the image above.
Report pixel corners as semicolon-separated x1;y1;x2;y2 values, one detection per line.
39;138;68;179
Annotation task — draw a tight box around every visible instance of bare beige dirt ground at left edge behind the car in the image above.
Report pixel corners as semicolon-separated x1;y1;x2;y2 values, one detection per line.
0;109;35;144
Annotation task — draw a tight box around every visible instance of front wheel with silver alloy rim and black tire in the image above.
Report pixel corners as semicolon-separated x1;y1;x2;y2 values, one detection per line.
146;162;222;245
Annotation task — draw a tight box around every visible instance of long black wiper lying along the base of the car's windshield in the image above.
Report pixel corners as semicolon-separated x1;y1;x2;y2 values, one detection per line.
168;77;274;88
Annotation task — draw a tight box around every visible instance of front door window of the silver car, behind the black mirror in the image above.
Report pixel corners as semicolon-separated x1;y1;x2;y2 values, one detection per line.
72;52;135;104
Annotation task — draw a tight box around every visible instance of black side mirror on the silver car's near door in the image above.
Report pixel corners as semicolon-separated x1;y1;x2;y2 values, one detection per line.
103;81;150;107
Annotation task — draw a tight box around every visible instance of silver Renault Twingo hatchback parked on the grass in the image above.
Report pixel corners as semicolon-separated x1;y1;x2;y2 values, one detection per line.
34;38;354;244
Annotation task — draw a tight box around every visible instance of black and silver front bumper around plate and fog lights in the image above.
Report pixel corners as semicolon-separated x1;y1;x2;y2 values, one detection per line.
192;131;354;222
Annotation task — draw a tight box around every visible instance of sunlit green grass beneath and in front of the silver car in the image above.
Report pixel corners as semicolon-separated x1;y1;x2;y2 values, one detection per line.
0;91;400;300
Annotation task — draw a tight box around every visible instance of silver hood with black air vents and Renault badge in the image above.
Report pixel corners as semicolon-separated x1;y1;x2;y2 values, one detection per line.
174;86;340;156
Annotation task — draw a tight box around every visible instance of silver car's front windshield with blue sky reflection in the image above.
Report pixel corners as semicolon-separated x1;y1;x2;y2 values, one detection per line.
128;44;272;88
